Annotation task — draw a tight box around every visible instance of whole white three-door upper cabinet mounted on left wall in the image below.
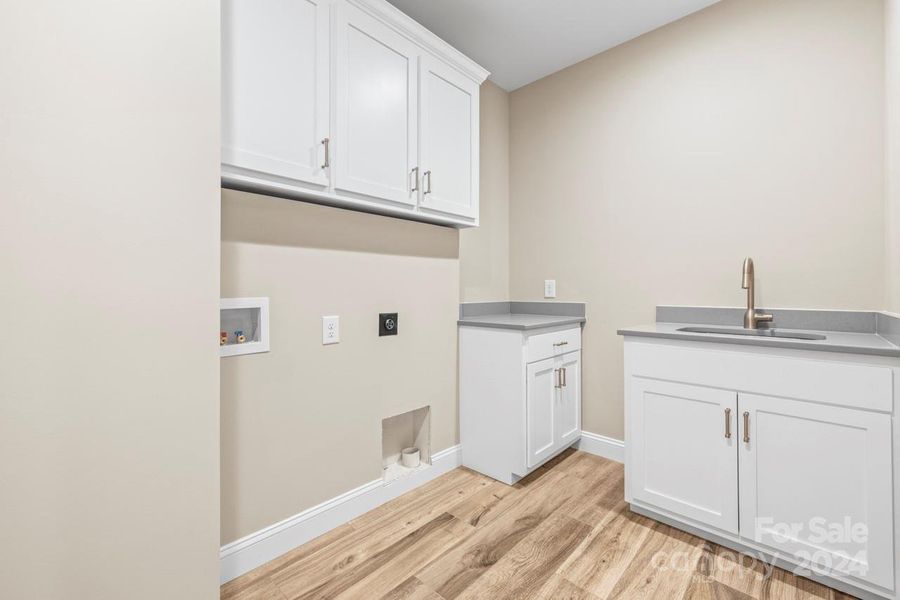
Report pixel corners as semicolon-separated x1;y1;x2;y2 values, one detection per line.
222;0;487;227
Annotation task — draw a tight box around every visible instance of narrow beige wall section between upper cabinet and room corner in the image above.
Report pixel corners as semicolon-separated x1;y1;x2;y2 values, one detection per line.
459;81;509;302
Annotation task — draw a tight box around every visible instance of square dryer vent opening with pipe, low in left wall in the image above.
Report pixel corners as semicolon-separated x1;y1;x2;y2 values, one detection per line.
381;406;431;481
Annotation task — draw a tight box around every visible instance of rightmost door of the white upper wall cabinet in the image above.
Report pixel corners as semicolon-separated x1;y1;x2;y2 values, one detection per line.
420;56;479;219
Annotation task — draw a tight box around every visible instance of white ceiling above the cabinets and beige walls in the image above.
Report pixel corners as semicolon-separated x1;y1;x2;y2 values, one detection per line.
388;0;718;91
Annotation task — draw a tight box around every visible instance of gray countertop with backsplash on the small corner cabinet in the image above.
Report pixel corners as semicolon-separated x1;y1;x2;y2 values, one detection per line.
457;301;585;331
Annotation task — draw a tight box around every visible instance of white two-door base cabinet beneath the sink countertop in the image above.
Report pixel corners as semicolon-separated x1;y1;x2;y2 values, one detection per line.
625;337;900;599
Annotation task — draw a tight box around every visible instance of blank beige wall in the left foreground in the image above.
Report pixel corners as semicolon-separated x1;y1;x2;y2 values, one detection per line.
0;0;219;600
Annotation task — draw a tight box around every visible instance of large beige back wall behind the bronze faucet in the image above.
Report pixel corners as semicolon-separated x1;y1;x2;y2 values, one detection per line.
510;0;885;438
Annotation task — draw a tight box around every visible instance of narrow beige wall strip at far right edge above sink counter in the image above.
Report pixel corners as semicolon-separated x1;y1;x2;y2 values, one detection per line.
884;0;900;313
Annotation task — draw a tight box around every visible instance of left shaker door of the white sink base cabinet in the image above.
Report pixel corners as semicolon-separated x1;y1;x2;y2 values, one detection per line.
628;377;738;533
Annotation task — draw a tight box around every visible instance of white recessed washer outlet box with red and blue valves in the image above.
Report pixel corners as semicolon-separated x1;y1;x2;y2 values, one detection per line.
219;298;269;356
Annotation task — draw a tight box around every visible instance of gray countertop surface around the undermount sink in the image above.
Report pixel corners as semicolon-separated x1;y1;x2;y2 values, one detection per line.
618;311;900;357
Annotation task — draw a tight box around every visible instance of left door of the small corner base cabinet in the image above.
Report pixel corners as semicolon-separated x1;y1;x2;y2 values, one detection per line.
525;359;557;468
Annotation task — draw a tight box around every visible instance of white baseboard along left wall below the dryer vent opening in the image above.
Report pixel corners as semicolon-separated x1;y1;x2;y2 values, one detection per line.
219;445;461;583
